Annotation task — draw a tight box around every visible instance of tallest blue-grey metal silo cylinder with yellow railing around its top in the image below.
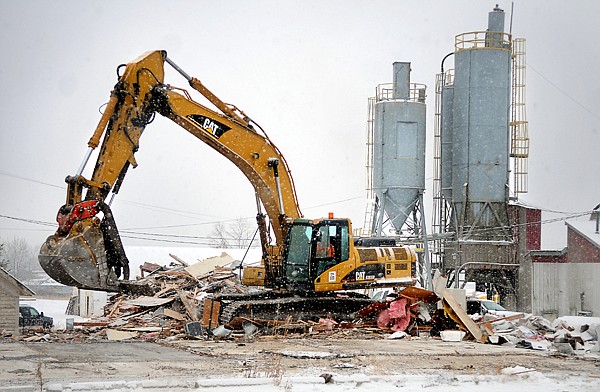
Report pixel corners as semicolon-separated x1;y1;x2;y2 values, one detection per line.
452;8;511;239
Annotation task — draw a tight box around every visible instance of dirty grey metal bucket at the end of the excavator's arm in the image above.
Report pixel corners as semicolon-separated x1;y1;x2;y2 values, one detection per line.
38;225;121;292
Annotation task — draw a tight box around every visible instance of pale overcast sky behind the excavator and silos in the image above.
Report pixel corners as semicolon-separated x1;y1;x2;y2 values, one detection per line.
0;0;600;249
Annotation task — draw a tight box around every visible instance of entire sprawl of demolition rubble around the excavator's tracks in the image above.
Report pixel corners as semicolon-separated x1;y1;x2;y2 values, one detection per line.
10;253;600;355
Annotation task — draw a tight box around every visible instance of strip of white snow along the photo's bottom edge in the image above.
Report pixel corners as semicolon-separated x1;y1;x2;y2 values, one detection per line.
43;367;600;392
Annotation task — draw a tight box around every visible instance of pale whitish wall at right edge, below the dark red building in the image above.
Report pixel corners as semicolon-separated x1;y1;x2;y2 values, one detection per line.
532;263;600;319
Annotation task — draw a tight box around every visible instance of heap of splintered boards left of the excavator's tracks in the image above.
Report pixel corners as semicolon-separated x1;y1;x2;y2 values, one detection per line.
98;253;248;340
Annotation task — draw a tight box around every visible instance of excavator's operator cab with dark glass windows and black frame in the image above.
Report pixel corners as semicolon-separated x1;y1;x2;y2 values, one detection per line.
283;219;350;291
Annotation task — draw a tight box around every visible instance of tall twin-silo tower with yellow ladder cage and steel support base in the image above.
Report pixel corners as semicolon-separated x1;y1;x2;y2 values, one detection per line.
431;5;529;308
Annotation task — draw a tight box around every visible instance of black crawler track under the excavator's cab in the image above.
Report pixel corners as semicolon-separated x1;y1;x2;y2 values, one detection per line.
215;293;373;324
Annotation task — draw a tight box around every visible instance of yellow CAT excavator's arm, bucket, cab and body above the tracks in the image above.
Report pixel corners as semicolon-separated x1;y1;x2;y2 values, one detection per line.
38;51;416;322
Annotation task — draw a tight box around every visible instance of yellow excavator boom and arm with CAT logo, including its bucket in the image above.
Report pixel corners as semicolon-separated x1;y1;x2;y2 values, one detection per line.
39;51;302;292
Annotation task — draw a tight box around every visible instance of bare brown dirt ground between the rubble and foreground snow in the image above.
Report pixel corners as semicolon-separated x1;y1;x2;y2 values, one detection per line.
0;337;600;391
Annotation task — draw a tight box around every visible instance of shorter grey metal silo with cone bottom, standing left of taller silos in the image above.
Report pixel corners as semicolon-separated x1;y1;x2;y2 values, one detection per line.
372;62;425;234
